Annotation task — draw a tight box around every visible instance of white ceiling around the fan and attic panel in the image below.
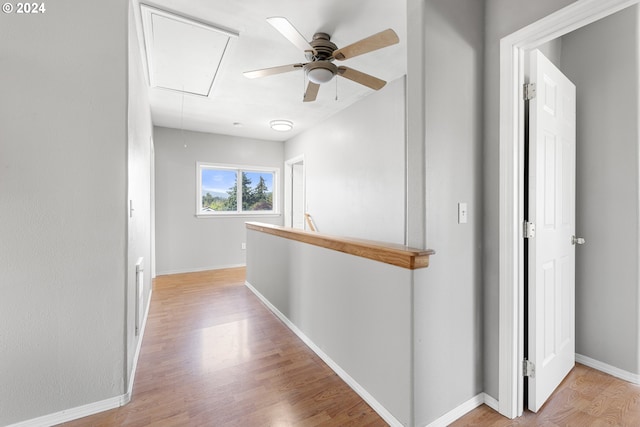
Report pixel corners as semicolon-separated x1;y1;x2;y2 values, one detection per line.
134;0;406;141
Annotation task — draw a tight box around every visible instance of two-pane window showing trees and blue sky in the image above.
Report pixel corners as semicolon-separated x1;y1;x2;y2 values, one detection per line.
196;163;279;215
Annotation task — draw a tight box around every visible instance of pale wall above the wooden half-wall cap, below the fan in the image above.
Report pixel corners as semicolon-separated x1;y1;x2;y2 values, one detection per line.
285;79;405;243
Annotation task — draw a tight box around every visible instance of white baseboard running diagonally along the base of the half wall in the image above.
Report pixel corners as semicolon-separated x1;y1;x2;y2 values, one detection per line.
244;281;403;427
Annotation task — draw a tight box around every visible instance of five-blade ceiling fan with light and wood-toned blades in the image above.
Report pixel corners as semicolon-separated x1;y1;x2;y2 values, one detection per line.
244;16;400;102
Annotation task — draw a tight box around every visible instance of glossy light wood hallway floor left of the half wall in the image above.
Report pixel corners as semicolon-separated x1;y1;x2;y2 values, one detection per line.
64;268;387;427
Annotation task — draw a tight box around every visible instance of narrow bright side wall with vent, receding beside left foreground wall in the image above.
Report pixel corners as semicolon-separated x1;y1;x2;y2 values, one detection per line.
126;1;153;384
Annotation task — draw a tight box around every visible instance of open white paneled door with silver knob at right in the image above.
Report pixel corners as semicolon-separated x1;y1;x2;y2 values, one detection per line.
527;50;576;412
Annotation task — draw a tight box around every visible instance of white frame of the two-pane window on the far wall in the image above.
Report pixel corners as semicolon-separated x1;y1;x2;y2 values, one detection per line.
196;162;280;218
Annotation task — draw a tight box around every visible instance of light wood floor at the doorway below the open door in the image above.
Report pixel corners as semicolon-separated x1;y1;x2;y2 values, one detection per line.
450;364;640;427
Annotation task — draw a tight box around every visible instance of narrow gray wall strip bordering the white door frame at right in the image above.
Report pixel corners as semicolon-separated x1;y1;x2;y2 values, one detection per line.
483;0;575;399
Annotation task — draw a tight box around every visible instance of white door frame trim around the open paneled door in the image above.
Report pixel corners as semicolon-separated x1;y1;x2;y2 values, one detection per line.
498;0;640;418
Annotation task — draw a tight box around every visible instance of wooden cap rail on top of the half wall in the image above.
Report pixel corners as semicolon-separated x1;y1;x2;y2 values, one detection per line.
246;222;435;270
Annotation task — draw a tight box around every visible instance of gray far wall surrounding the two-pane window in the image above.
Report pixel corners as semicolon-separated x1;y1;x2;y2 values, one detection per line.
154;127;284;275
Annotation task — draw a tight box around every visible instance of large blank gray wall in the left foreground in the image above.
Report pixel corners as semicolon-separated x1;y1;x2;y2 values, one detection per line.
0;0;128;425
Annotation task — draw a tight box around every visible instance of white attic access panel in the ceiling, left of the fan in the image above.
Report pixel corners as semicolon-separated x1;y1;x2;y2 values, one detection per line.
140;5;238;96
